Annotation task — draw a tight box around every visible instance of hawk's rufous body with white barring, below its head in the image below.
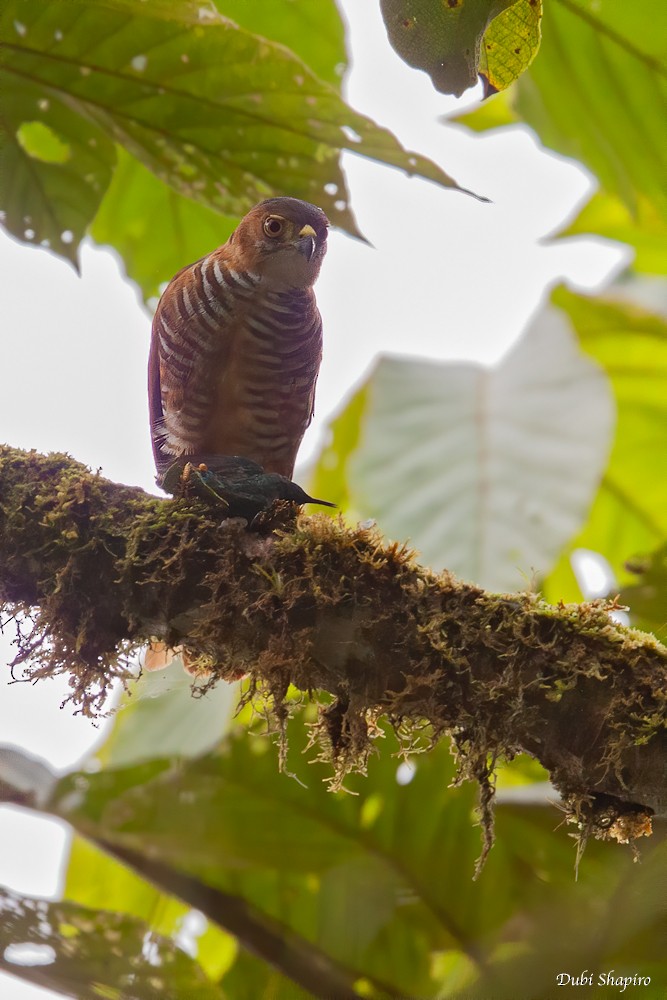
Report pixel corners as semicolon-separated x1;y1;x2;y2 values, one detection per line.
149;248;322;478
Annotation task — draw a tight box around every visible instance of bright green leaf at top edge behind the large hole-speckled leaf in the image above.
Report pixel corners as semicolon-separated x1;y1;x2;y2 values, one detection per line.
216;0;347;89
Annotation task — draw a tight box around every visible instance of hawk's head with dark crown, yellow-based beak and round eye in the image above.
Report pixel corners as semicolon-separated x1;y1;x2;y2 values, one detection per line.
230;198;329;288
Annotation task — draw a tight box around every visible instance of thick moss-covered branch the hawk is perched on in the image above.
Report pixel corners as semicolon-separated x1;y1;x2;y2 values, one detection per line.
0;448;667;840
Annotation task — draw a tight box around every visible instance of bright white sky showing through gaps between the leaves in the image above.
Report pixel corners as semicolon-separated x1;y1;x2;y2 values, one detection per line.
0;0;628;1000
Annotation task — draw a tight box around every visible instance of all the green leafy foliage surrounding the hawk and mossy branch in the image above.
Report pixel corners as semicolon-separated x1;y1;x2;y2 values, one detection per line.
0;0;667;1000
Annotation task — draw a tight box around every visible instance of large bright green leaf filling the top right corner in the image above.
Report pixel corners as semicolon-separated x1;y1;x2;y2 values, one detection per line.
460;0;667;217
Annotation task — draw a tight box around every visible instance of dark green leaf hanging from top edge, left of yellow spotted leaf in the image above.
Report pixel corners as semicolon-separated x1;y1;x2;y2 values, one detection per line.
380;0;516;97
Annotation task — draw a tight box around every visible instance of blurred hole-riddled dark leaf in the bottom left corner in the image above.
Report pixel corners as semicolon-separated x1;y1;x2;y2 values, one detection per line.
0;889;223;1000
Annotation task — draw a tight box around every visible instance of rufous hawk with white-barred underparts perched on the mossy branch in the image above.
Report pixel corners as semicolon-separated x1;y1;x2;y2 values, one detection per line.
148;198;328;480
